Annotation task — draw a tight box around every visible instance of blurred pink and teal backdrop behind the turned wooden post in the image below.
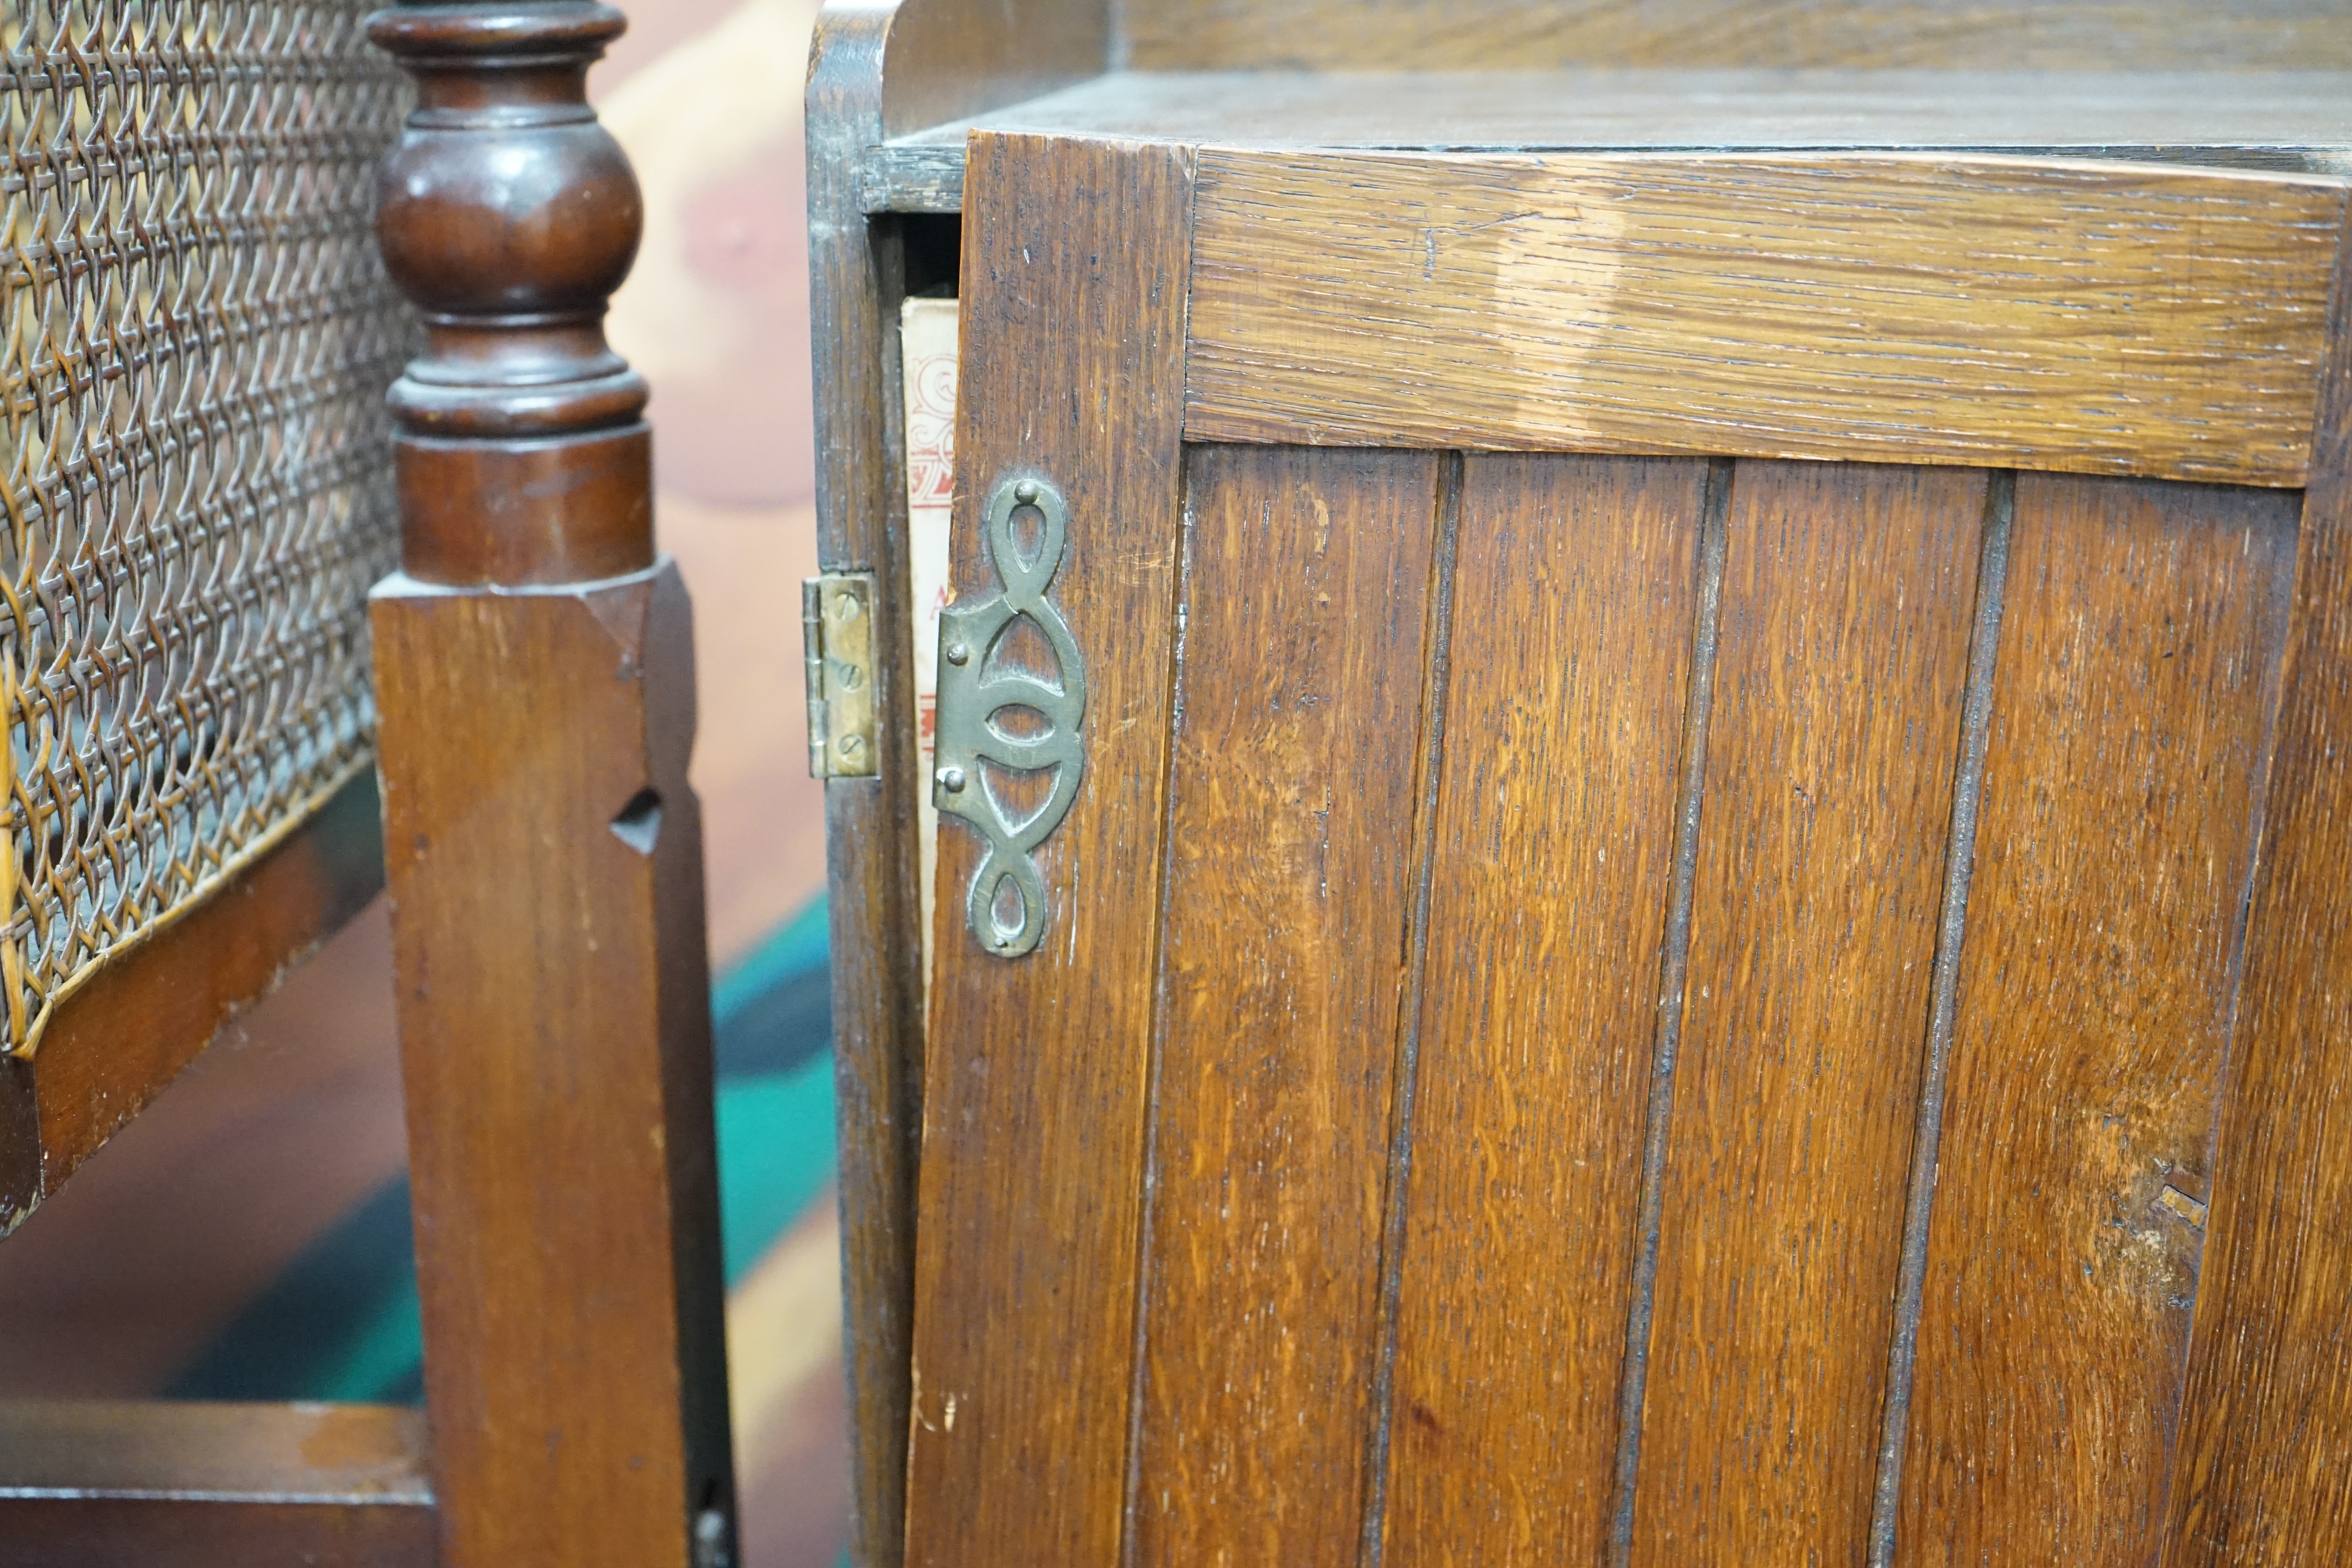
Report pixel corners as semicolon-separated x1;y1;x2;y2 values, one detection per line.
0;0;849;1568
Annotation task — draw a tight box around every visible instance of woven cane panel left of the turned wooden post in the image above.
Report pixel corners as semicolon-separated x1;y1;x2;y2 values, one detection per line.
0;0;409;1053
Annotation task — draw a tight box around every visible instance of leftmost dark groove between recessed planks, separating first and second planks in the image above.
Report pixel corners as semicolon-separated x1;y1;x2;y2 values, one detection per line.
1357;451;1463;1568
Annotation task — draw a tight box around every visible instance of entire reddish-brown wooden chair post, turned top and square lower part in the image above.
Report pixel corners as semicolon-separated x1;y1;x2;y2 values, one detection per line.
372;0;734;1568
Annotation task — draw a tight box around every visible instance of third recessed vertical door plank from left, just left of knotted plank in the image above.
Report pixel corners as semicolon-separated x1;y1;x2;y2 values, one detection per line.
1633;463;1985;1568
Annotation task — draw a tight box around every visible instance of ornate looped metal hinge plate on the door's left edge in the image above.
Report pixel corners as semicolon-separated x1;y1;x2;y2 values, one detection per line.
931;475;1086;959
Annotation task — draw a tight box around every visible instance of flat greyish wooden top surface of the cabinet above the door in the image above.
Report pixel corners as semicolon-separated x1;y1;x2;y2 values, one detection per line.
861;66;2352;212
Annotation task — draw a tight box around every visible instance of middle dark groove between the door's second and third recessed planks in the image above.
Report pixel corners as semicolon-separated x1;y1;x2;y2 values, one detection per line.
1609;458;1738;1568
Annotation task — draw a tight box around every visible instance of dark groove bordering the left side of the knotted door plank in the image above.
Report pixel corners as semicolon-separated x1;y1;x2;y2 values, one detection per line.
1870;470;2018;1568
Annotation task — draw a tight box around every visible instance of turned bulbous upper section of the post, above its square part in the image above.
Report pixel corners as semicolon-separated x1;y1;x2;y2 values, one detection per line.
367;0;654;586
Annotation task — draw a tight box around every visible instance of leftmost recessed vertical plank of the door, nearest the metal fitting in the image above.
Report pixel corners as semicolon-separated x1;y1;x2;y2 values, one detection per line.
1134;447;1440;1568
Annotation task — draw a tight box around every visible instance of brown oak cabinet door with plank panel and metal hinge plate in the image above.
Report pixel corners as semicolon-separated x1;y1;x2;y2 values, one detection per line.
908;134;2352;1568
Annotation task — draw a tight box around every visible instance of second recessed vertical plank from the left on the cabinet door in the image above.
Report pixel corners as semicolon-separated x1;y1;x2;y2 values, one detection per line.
1383;456;1708;1568
